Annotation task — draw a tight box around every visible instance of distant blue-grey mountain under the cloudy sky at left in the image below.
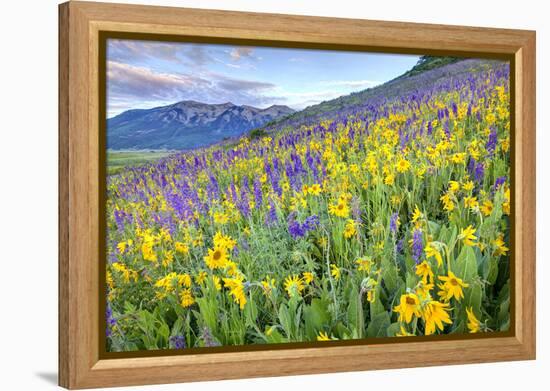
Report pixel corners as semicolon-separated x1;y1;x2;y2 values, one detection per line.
107;100;294;150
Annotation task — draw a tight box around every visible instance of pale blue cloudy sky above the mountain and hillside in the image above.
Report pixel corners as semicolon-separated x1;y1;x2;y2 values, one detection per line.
107;39;418;118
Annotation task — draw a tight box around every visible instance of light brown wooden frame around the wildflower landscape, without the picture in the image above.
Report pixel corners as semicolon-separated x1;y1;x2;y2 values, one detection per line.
59;1;536;389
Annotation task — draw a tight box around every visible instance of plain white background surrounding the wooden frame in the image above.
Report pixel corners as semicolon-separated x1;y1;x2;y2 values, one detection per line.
0;0;550;391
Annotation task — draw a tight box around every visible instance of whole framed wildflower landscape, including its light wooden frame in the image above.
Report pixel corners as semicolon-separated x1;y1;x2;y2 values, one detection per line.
59;2;535;388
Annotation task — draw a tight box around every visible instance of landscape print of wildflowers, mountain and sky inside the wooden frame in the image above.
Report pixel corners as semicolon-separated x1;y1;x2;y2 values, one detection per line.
104;39;512;352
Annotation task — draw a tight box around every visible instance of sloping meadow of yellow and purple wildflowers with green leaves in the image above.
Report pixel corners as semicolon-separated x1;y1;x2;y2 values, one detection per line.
106;62;512;351
